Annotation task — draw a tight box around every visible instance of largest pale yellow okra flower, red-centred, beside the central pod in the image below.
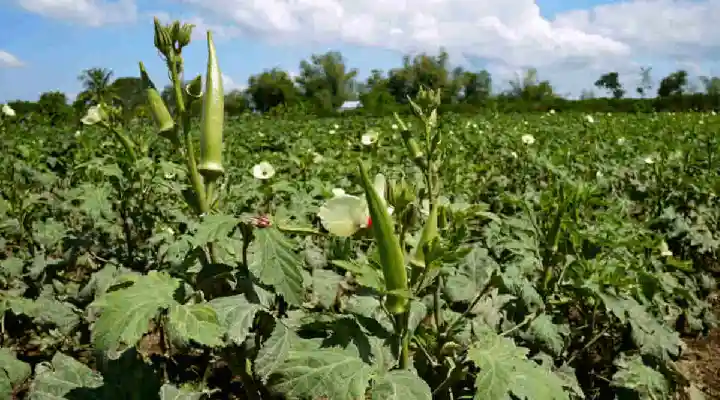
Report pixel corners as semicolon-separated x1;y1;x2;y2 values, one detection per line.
318;174;393;237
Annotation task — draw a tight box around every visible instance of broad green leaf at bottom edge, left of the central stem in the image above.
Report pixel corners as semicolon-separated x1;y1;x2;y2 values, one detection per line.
269;348;373;400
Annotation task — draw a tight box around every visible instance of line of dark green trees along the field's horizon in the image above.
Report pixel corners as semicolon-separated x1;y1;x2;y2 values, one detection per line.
9;51;720;123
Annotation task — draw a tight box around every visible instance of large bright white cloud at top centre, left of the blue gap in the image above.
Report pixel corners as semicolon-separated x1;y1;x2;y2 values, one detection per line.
180;0;631;67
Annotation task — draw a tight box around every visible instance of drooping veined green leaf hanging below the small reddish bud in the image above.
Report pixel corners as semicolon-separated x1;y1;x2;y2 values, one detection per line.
248;228;304;305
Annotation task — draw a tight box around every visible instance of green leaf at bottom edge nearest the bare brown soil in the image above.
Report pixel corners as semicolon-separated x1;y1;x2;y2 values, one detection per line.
611;355;671;400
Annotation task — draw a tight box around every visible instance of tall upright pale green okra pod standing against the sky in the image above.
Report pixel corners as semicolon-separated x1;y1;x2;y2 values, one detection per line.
198;31;225;182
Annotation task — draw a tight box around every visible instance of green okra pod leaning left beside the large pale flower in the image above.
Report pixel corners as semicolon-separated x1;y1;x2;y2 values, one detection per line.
358;161;408;314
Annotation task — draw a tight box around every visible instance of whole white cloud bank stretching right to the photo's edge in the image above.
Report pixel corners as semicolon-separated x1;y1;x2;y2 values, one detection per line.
170;0;720;92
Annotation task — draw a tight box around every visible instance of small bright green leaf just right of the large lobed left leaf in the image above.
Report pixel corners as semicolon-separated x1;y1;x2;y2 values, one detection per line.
168;304;225;347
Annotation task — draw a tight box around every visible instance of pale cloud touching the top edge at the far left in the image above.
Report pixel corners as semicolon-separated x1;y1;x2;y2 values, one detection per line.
18;0;137;27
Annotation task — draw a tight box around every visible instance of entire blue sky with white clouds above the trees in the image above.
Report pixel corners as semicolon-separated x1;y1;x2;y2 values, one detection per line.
0;0;720;103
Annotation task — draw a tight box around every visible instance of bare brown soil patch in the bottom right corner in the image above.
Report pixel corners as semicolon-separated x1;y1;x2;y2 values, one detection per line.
678;301;720;400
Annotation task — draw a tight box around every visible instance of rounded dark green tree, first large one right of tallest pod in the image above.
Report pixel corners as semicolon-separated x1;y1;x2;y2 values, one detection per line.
247;68;300;112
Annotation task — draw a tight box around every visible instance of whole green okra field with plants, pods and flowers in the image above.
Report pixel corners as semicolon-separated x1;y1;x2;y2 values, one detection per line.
0;18;720;400
